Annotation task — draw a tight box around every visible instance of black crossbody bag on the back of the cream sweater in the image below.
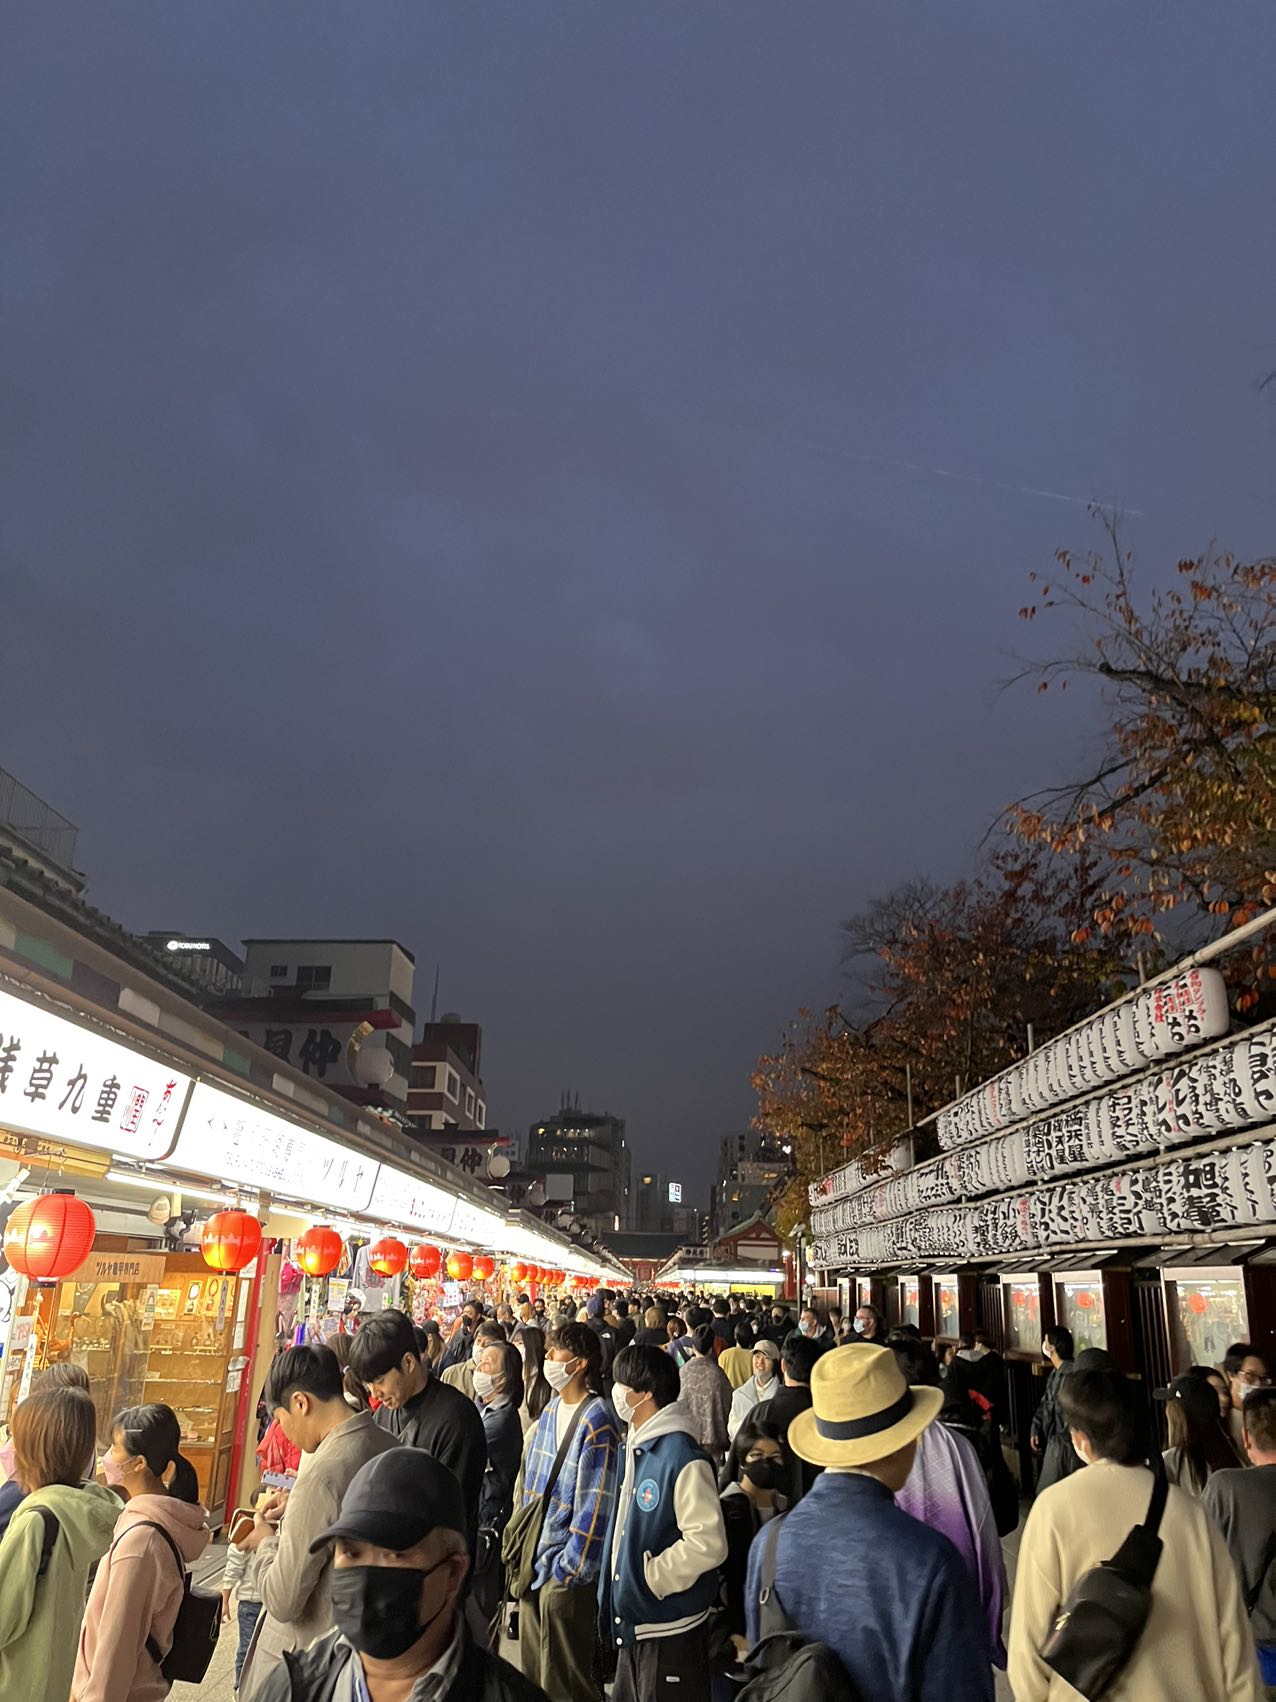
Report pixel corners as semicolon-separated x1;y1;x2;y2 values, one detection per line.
1041;1471;1169;1702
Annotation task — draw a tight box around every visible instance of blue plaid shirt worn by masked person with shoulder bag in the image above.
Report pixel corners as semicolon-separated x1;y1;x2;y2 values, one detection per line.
522;1396;621;1590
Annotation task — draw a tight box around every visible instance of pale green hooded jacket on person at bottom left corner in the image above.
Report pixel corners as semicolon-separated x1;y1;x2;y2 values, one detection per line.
0;1484;119;1702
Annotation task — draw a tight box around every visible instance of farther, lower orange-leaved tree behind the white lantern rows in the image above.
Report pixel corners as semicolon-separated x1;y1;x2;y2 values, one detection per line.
754;849;1130;1231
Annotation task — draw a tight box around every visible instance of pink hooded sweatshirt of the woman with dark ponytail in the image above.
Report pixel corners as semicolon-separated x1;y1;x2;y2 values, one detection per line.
71;1494;209;1702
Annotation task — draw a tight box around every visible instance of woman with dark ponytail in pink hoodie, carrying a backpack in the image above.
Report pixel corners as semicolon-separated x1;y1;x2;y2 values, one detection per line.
71;1406;209;1702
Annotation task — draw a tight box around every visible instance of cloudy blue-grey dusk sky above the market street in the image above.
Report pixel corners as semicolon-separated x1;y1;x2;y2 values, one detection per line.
0;0;1276;1193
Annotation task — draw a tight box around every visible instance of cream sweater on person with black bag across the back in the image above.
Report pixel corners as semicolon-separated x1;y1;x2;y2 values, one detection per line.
1009;1460;1264;1702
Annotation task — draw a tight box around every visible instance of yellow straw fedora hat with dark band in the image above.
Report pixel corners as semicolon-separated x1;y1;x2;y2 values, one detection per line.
789;1341;944;1465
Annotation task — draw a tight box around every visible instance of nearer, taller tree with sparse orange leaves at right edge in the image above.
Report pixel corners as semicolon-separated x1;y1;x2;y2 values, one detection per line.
1011;521;1276;1011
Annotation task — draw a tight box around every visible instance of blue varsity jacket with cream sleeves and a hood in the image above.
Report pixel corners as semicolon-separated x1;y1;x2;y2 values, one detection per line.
599;1401;726;1648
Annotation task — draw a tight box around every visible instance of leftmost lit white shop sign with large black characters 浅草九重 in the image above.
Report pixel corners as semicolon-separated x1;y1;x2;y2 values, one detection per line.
0;992;191;1159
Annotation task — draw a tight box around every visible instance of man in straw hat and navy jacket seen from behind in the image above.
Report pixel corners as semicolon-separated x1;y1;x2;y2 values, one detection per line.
747;1343;992;1702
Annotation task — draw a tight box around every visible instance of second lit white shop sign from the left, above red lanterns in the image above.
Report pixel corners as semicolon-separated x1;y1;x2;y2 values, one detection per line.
168;1081;381;1212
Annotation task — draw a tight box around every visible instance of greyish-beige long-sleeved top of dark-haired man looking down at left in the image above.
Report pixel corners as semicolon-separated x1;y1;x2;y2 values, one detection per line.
240;1413;400;1702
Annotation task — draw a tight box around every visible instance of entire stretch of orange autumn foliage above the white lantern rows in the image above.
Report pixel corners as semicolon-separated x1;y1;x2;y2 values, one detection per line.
754;523;1276;1231
